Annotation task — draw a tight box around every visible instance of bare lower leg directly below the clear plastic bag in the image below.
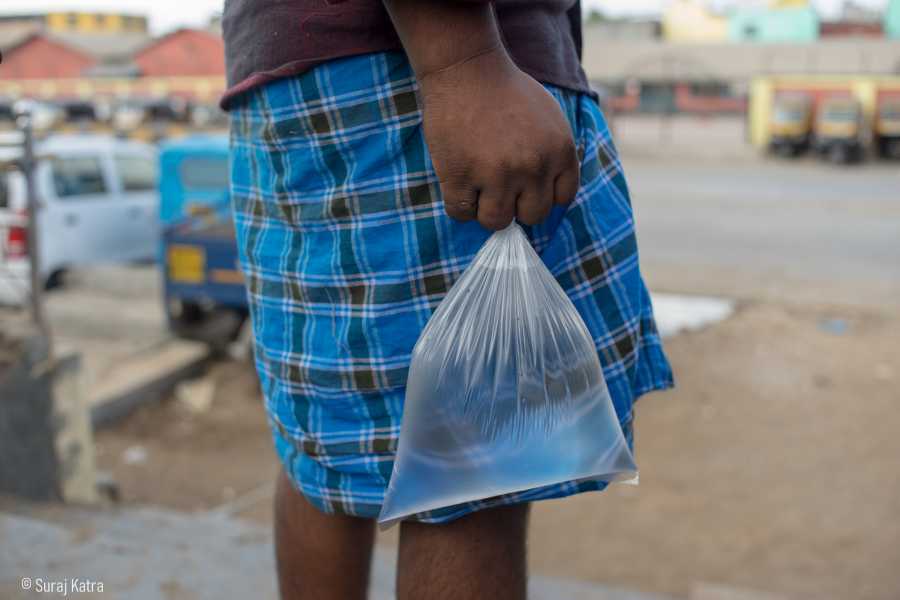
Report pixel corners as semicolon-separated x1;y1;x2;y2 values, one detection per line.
397;504;528;600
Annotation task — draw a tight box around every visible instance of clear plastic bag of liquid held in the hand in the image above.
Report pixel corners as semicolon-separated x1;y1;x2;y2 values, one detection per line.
378;223;637;525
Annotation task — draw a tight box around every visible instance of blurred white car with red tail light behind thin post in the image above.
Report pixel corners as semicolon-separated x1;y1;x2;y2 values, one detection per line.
0;135;159;304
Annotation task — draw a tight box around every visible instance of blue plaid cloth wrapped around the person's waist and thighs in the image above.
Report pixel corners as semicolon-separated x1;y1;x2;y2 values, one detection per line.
231;52;672;522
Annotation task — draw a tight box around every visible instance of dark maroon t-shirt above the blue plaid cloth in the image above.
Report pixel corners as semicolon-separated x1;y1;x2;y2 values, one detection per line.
222;0;590;109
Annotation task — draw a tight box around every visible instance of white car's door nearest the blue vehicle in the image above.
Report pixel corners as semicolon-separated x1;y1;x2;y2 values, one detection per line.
112;149;159;261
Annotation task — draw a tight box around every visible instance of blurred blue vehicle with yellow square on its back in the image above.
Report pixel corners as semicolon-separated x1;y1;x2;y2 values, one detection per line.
159;135;247;349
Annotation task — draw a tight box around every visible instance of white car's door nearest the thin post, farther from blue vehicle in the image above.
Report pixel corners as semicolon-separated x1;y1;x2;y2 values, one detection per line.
38;151;117;268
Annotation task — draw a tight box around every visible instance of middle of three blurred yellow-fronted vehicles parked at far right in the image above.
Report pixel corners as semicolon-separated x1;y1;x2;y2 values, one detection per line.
813;96;865;164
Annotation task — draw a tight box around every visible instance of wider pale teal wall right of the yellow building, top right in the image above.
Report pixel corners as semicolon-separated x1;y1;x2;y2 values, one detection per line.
728;7;819;42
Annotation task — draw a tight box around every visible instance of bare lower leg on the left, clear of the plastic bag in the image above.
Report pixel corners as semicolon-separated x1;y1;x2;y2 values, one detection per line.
275;472;375;600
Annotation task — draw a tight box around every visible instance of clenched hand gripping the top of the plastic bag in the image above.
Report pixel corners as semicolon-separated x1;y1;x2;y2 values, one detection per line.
419;47;579;230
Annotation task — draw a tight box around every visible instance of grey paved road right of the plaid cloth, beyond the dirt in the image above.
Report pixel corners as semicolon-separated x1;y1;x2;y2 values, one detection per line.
625;156;900;307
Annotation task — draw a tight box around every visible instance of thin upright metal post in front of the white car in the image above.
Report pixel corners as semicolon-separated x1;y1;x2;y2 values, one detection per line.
16;107;53;360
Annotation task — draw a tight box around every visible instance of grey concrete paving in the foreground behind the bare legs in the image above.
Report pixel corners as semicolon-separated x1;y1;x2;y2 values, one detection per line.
0;507;674;600
